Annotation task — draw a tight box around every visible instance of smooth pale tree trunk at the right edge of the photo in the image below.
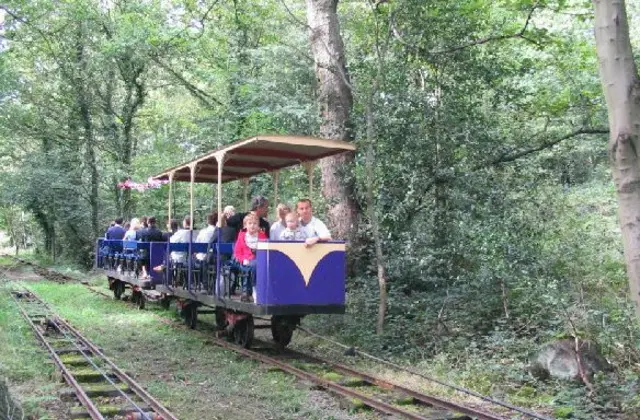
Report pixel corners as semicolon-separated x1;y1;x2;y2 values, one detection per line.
593;0;640;315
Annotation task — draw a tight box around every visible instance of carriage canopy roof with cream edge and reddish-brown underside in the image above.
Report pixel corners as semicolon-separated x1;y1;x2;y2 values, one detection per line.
152;135;356;183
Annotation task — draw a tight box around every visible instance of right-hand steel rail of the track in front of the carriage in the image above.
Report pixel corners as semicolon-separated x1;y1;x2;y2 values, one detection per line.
287;350;505;420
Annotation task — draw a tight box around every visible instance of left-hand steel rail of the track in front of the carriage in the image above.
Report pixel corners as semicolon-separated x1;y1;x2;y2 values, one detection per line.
214;339;482;420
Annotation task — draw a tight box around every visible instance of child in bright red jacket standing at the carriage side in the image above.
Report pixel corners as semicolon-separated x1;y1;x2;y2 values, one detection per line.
233;213;267;302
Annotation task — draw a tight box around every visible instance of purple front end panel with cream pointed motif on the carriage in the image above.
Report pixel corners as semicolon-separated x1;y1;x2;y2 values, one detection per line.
256;241;346;305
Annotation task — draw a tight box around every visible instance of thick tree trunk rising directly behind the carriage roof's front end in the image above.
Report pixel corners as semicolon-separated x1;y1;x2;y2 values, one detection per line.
307;0;357;241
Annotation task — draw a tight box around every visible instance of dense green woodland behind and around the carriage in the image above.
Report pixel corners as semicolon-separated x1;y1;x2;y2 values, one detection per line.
0;0;640;418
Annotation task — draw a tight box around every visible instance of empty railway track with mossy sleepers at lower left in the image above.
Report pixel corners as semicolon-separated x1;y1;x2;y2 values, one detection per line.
11;290;177;420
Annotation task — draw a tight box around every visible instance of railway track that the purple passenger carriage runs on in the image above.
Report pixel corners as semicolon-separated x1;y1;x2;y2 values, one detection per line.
1;261;548;420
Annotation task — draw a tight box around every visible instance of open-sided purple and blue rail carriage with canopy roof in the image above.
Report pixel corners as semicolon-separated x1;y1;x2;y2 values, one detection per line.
96;135;355;347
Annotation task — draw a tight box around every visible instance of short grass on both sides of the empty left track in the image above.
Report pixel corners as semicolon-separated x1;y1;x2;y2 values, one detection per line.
0;261;360;419
